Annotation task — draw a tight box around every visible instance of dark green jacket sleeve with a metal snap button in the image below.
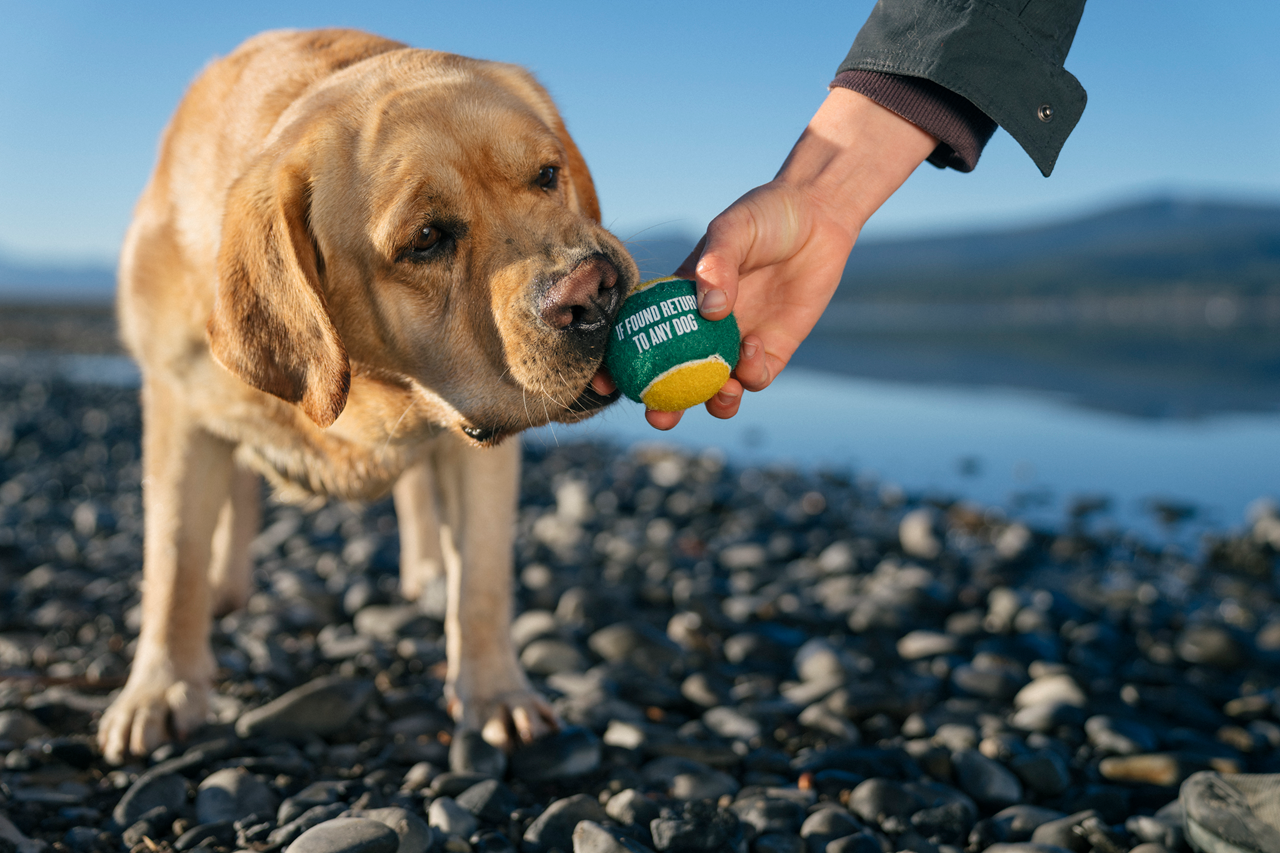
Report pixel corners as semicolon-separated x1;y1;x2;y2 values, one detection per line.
837;0;1085;177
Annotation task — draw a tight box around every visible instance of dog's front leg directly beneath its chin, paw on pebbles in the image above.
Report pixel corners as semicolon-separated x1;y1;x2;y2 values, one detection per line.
438;438;559;749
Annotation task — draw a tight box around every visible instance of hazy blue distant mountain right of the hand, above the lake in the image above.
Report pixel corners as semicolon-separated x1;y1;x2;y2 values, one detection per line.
836;199;1280;301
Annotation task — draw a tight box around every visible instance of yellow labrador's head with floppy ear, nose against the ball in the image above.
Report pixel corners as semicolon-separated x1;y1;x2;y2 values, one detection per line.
209;49;637;443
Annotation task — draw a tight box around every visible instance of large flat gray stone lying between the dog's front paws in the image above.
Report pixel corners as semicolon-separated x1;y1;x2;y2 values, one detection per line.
236;675;375;738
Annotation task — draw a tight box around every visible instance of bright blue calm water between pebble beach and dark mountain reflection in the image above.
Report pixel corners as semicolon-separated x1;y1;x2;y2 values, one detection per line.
12;355;1280;542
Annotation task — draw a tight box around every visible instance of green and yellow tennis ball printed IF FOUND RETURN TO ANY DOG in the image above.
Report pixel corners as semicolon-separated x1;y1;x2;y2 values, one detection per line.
604;278;739;411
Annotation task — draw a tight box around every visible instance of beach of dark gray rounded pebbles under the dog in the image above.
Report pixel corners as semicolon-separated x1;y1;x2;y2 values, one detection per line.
0;374;1280;853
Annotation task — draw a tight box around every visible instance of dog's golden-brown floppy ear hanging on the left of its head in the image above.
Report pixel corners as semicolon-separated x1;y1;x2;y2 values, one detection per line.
207;146;351;427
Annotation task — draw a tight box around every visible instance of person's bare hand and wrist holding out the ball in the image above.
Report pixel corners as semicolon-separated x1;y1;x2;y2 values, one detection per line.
645;88;937;429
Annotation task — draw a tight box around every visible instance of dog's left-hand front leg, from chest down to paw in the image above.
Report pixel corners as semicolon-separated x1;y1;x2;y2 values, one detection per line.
97;380;234;763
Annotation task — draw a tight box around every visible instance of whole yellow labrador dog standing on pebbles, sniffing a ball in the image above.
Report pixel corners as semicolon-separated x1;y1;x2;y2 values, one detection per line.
99;29;637;762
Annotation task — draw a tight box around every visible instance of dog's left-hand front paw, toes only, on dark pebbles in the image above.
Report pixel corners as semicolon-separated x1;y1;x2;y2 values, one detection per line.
97;666;210;765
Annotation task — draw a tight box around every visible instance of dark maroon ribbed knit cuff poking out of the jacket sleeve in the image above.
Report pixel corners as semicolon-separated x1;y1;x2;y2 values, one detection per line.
831;70;996;172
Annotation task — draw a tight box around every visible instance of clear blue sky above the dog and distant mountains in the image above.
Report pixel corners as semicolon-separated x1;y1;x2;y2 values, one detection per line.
0;0;1280;261
